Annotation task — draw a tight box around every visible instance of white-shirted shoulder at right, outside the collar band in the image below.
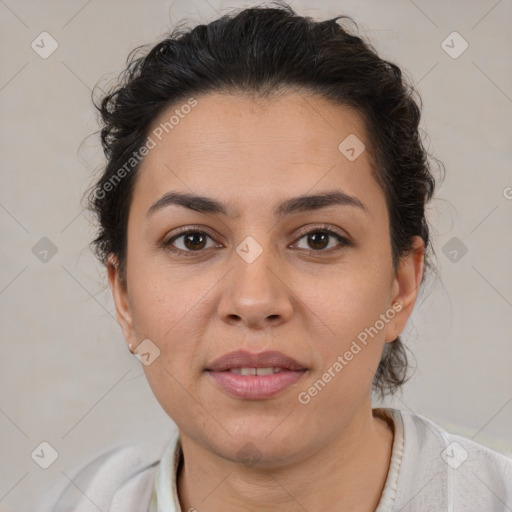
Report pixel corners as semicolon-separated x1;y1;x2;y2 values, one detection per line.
393;409;512;511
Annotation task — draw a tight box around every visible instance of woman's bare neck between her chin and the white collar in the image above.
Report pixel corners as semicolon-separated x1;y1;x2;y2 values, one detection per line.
178;405;393;512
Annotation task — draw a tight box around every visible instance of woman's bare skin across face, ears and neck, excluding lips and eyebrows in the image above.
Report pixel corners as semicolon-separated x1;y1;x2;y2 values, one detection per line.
108;92;424;512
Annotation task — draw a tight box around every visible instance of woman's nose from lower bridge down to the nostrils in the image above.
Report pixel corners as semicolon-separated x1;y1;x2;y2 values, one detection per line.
218;241;294;329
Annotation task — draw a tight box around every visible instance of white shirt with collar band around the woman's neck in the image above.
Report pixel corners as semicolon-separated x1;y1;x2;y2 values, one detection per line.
44;408;512;512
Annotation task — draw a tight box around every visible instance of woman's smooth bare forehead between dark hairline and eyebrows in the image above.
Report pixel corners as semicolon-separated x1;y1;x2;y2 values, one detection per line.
130;93;379;218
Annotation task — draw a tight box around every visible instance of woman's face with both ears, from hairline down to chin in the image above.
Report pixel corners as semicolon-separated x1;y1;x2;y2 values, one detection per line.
109;93;422;466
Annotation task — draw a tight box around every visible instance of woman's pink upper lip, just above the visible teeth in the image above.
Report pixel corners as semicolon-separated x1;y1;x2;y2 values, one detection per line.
206;350;306;372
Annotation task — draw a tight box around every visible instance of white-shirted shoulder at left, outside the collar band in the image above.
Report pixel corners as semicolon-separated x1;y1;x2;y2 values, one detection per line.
45;442;169;512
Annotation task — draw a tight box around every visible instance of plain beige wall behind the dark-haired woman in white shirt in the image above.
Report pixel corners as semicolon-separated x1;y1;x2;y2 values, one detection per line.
0;0;512;512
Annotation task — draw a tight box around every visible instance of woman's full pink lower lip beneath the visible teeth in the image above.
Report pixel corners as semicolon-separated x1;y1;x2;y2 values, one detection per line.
207;370;305;400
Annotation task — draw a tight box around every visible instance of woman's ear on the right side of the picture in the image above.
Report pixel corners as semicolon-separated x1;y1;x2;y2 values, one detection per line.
386;236;425;342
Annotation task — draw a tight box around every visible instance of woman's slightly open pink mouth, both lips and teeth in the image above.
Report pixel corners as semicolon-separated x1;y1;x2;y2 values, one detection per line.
205;350;308;400
